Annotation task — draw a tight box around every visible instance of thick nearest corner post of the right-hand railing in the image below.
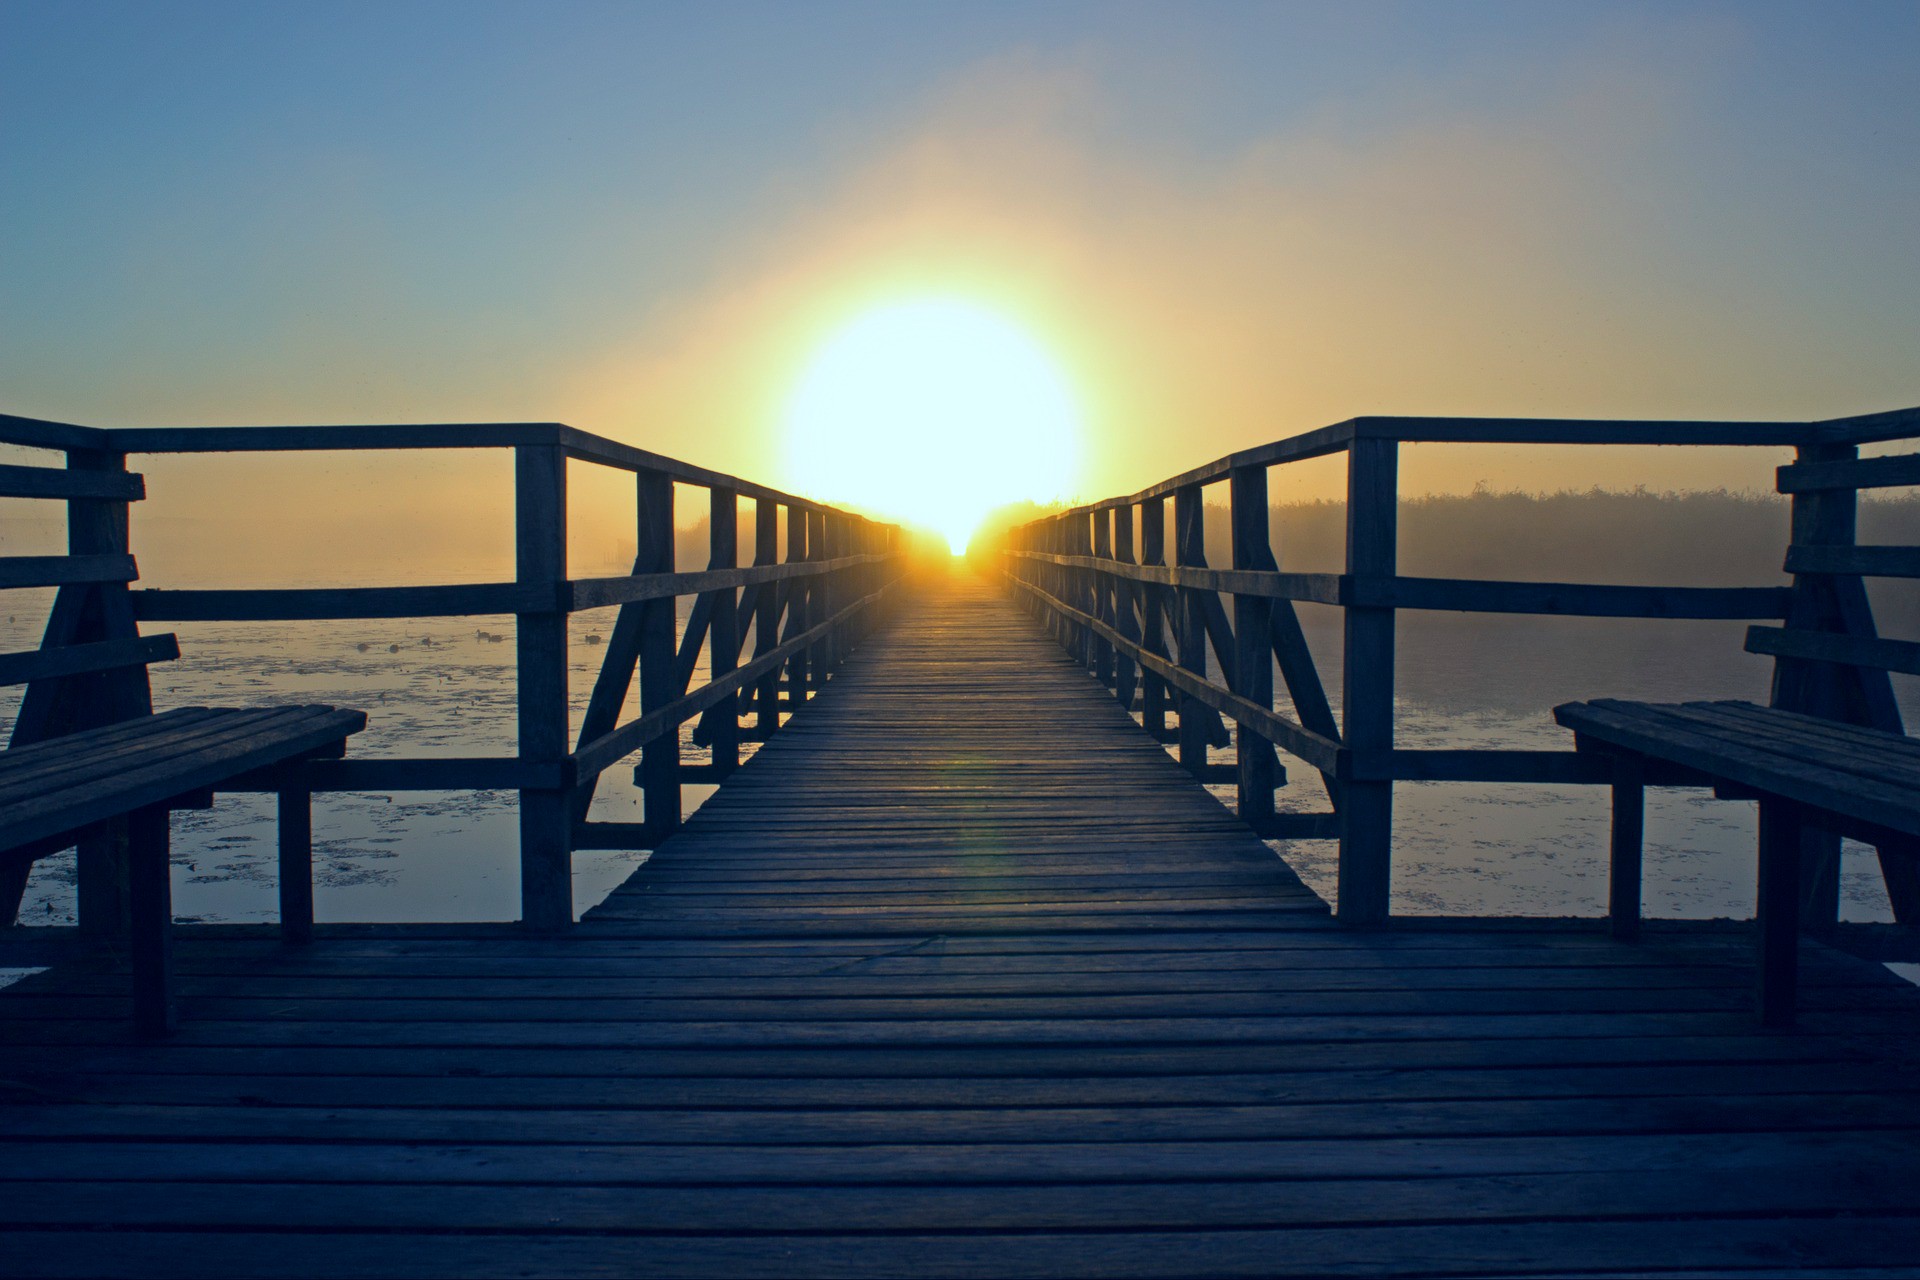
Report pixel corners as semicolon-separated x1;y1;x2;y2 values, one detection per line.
1336;438;1400;925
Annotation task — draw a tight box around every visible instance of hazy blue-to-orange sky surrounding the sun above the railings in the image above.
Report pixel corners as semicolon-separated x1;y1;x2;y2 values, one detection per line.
0;0;1920;552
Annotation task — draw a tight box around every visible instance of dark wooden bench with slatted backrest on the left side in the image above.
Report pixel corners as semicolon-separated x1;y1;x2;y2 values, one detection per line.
0;451;367;1036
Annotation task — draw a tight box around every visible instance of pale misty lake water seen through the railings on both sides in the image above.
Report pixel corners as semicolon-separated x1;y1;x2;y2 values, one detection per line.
0;595;1914;925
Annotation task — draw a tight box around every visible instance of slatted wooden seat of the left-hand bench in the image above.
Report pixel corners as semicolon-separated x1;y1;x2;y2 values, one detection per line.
0;706;367;846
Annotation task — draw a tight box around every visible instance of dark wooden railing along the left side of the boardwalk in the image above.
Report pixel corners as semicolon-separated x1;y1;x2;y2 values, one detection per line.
0;415;904;929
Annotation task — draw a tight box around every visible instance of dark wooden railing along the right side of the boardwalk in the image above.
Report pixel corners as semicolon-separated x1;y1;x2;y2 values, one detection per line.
1002;409;1920;925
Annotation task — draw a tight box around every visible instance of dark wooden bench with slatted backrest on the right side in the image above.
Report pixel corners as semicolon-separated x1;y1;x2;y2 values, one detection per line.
1553;435;1920;1027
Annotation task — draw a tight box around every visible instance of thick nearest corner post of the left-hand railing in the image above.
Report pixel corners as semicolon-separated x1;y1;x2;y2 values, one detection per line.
513;445;574;933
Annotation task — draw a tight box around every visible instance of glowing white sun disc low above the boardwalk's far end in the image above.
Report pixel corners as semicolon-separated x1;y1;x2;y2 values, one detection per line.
787;297;1079;555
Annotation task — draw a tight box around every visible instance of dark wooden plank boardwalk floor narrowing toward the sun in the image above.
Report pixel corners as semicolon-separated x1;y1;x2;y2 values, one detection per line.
0;580;1920;1276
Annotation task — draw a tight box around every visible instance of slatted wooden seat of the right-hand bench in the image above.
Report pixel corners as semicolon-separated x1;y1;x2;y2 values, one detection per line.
1553;699;1920;835
